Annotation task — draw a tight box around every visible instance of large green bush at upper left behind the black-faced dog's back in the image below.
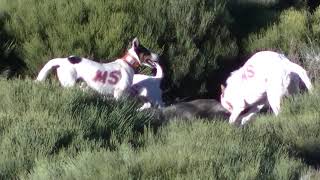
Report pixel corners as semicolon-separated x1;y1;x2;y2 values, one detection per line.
2;0;163;75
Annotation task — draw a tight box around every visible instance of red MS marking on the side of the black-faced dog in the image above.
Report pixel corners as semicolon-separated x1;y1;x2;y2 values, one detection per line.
93;70;121;85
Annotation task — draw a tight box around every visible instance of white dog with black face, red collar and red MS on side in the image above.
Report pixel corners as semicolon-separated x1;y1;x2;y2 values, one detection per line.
36;38;158;99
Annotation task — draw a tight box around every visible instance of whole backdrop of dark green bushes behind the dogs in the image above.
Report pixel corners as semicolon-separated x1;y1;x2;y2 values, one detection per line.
0;0;316;102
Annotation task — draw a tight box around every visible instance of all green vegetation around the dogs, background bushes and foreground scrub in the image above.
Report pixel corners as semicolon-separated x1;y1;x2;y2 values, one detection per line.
0;0;320;179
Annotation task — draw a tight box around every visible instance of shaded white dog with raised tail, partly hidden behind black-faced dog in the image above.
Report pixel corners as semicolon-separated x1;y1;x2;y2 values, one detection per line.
131;62;163;110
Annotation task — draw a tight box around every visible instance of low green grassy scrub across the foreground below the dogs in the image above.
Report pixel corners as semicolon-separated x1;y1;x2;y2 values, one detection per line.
0;79;320;179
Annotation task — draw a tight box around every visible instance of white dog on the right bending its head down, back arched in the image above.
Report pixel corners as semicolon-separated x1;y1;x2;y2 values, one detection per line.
221;51;312;125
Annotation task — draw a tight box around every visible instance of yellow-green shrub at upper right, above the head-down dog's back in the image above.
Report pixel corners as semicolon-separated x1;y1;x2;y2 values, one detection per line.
245;8;320;80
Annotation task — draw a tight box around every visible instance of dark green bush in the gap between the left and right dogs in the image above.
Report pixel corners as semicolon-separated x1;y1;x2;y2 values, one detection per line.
165;0;238;100
